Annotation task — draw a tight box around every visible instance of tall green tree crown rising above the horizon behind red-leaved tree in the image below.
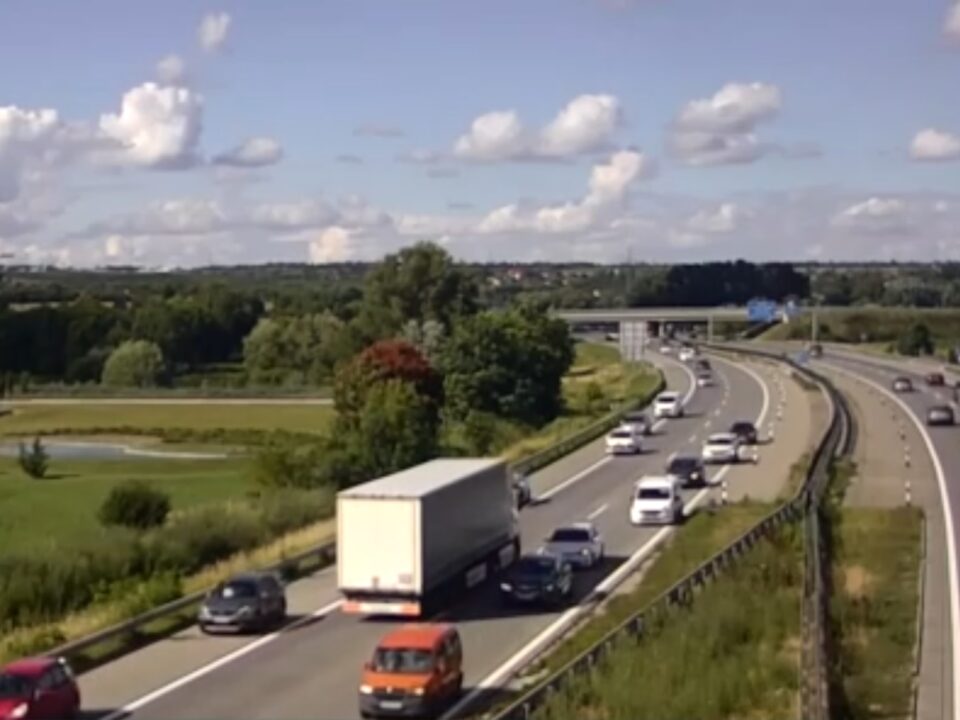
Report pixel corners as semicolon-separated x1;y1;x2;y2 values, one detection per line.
361;242;479;339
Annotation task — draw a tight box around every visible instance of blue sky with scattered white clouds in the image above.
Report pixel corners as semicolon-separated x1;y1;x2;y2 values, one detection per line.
0;0;960;268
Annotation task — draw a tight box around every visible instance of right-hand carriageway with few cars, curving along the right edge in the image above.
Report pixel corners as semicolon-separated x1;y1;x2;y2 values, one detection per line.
808;348;960;720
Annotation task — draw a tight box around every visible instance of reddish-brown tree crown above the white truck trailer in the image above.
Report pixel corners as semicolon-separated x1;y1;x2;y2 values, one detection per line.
334;340;443;426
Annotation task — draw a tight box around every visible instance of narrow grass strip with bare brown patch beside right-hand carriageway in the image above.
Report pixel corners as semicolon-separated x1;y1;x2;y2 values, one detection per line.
831;507;923;720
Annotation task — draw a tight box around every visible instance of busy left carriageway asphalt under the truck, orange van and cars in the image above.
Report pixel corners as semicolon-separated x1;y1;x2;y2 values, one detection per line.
80;358;770;720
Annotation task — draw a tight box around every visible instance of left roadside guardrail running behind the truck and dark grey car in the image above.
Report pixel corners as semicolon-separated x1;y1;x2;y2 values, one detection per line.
43;360;666;667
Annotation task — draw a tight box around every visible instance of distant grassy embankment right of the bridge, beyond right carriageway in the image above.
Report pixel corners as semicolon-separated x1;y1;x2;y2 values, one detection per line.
759;307;960;346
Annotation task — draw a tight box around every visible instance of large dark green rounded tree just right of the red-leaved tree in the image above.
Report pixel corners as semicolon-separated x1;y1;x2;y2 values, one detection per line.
443;306;574;425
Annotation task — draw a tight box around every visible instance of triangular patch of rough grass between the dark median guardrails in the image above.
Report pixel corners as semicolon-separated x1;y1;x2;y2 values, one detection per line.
533;526;803;720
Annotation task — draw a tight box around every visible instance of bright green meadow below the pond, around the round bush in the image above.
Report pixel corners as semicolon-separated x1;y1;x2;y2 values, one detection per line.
0;458;251;553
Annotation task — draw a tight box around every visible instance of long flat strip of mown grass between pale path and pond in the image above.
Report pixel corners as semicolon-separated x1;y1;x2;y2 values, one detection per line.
0;403;333;436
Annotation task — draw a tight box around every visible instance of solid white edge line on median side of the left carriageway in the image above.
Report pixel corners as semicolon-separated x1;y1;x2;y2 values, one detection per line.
440;356;770;720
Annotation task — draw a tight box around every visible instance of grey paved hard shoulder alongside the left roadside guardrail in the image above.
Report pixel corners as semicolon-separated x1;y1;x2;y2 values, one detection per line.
80;359;692;707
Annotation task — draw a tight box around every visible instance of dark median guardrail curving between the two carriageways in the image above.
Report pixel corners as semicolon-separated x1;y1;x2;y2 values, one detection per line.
484;343;852;720
